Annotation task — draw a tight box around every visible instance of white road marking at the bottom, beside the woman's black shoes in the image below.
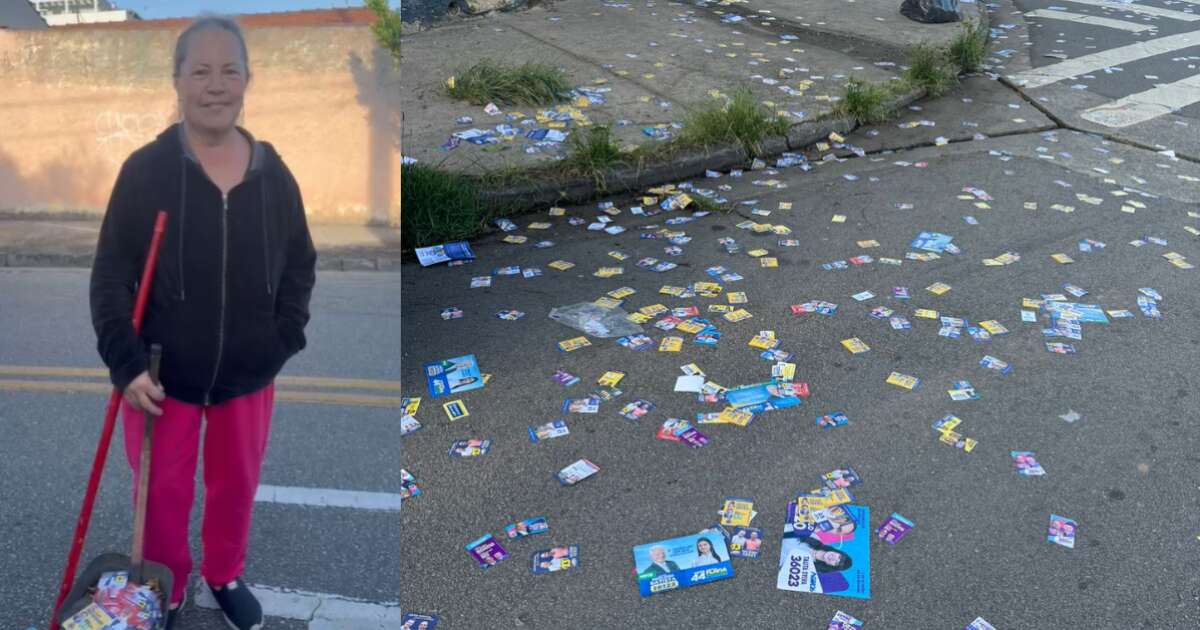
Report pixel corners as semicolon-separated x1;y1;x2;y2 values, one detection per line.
196;583;400;630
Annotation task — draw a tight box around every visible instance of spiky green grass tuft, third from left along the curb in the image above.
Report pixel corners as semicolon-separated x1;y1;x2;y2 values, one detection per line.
679;88;791;155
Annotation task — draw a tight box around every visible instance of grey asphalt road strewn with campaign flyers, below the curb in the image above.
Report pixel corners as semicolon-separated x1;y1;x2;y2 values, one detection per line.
401;73;1200;629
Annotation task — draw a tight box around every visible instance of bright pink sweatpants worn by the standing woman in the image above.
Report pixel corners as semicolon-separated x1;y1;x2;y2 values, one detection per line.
121;384;275;604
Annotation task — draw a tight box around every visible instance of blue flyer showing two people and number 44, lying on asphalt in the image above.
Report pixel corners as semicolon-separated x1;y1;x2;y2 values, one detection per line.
634;532;733;598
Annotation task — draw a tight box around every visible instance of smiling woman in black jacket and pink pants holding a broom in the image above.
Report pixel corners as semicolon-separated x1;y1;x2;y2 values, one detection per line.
91;16;316;630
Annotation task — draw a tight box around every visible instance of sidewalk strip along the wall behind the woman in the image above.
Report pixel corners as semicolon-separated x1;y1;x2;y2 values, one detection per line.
0;218;400;271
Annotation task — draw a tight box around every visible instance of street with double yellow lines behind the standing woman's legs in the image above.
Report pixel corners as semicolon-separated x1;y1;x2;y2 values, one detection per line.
0;269;400;630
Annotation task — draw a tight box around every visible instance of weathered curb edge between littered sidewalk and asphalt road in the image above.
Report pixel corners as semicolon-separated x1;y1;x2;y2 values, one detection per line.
480;89;925;212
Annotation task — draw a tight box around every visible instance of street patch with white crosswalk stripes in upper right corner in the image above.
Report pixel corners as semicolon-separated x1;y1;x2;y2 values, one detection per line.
1009;0;1200;157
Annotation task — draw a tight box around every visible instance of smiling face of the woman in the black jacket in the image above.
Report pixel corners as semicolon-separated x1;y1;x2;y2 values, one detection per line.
175;29;248;133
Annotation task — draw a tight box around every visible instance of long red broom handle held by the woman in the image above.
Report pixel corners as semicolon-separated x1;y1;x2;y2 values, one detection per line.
50;210;167;630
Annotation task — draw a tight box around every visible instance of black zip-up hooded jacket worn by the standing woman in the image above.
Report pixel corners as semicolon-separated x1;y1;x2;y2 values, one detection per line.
91;124;317;404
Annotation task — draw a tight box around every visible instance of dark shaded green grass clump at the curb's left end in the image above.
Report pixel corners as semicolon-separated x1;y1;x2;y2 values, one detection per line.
400;163;488;248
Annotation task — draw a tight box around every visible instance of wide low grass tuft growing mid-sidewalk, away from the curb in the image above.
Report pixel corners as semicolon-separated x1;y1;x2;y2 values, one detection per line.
446;60;571;106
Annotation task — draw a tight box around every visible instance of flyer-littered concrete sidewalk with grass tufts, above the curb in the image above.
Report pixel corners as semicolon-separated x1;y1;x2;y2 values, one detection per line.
401;0;983;175
